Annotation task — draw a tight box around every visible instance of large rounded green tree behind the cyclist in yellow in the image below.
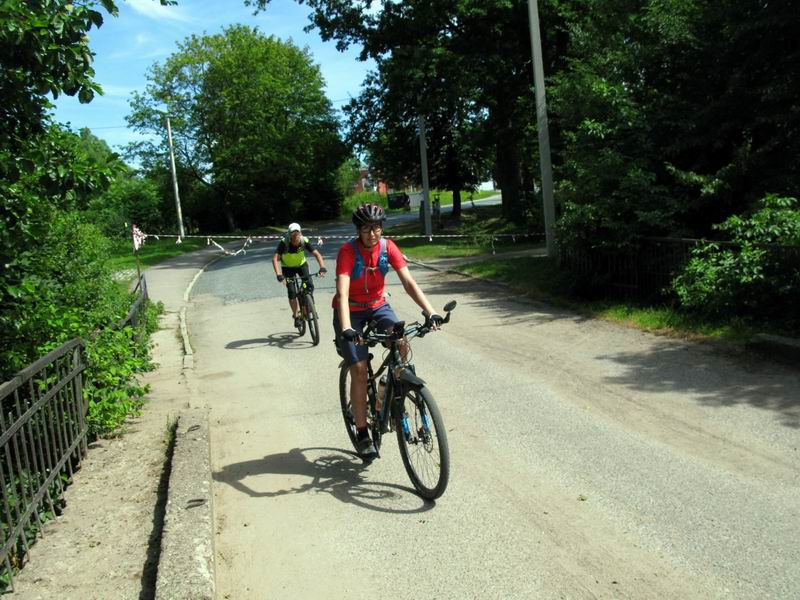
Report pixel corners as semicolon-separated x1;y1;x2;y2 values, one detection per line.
128;25;347;228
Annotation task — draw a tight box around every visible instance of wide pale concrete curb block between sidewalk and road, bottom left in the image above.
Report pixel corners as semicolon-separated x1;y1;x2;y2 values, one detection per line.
155;409;215;600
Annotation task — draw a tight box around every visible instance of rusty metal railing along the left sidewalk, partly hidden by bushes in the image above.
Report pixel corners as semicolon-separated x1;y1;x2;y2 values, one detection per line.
0;275;147;592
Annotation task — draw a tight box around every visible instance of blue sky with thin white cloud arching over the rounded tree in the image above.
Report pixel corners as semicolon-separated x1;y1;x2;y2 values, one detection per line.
55;0;372;150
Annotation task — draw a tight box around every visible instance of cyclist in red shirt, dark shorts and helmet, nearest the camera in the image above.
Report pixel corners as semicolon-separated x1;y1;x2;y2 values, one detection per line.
333;204;442;459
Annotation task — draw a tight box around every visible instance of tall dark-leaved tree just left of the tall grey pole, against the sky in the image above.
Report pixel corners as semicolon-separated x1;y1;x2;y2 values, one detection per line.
246;0;567;220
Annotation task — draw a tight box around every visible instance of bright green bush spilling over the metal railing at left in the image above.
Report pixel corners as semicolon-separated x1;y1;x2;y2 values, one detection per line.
0;212;161;435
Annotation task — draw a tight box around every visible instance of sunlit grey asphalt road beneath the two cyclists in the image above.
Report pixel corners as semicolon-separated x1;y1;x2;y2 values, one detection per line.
188;228;800;600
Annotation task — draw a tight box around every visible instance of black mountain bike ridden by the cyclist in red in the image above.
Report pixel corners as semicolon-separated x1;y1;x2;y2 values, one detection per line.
339;300;456;500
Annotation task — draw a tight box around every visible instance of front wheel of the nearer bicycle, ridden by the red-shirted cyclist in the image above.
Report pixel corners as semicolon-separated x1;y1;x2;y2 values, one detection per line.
394;386;450;500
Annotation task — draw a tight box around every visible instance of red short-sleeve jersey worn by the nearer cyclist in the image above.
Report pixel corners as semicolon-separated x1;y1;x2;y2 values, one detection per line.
333;240;406;311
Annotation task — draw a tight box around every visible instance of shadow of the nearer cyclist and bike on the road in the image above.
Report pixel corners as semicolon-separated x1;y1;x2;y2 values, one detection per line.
213;447;436;514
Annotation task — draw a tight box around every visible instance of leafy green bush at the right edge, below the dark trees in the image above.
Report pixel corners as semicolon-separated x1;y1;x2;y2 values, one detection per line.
672;195;800;319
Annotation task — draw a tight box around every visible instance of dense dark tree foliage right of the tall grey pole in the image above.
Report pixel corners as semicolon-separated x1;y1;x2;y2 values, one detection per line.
549;0;800;246
